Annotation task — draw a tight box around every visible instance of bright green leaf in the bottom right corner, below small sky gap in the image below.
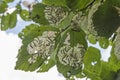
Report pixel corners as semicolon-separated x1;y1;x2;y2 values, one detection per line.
100;46;120;80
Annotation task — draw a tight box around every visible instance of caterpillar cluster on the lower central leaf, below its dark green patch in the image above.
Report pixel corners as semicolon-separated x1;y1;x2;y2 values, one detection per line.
57;44;85;68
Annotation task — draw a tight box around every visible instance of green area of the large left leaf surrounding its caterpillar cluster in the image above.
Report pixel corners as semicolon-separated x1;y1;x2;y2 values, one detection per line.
15;24;56;71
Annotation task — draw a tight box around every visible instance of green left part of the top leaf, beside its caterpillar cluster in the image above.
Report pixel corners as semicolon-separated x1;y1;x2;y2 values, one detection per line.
31;3;49;25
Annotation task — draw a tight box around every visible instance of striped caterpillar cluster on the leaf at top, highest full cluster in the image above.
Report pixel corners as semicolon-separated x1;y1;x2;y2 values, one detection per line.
44;6;68;25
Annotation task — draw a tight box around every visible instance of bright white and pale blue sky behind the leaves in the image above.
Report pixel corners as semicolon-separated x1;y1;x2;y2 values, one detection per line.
0;0;111;80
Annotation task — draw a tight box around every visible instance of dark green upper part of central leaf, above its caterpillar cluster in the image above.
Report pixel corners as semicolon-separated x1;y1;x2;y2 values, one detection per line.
70;30;87;49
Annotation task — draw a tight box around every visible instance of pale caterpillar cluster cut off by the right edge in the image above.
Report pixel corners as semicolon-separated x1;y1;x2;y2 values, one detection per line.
114;27;120;60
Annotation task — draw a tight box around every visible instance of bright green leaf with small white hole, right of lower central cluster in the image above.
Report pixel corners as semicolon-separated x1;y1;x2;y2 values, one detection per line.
83;47;101;80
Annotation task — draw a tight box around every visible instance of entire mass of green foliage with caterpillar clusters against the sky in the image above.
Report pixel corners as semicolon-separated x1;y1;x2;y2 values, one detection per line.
0;0;120;80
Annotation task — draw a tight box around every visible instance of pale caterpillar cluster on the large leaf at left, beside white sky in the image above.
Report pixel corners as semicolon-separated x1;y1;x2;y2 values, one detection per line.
27;31;55;63
